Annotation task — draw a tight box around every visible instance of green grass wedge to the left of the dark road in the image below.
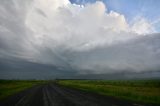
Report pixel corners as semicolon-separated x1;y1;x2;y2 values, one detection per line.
0;80;45;100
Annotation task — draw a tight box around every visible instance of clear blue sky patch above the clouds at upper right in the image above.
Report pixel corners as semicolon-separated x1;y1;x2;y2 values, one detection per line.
70;0;160;32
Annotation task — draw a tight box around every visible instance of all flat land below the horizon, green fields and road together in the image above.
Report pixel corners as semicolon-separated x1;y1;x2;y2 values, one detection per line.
0;80;159;106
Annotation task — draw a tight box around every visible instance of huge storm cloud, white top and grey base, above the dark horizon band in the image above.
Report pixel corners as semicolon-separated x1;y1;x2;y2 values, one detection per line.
0;0;160;73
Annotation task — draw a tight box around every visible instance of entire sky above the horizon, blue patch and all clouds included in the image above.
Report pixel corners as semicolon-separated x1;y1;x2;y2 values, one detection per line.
0;0;160;79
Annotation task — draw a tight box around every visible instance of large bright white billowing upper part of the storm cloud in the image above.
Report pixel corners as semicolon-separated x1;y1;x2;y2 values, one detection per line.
25;0;132;49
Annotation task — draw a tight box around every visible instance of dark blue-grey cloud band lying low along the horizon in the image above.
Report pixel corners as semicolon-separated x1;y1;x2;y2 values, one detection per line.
0;57;160;79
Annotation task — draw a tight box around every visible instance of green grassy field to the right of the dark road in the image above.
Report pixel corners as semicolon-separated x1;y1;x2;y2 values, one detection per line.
58;80;160;104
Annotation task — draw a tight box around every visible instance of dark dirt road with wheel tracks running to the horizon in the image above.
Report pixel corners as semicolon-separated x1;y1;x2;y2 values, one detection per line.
0;83;155;106
